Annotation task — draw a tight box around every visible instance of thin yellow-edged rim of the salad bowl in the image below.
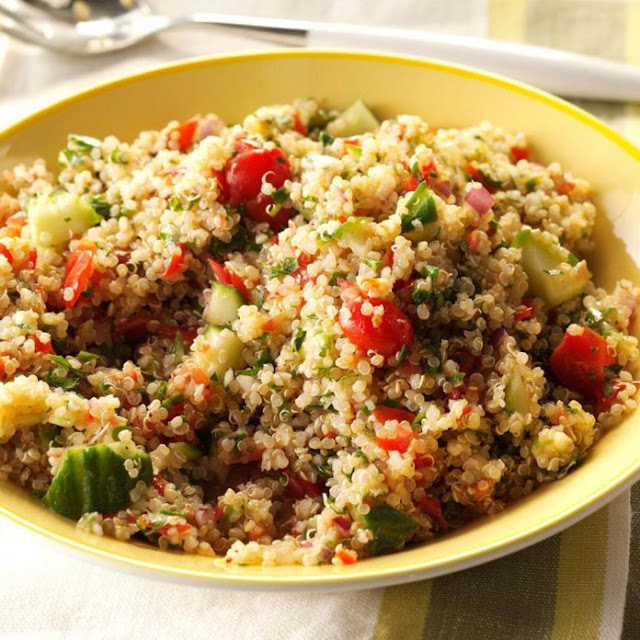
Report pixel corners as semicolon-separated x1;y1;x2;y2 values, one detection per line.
0;49;640;591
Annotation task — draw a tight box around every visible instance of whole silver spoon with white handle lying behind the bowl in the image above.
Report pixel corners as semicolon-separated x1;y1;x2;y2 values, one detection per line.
0;0;640;101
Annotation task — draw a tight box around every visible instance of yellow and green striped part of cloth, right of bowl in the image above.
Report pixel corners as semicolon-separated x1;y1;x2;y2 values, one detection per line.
373;0;640;640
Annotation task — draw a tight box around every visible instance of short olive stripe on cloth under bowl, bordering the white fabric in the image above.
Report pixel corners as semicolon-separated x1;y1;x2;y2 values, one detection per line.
373;580;432;640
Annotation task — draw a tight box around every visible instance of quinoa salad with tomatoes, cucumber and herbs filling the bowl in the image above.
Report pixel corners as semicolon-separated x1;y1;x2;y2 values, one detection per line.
0;100;640;564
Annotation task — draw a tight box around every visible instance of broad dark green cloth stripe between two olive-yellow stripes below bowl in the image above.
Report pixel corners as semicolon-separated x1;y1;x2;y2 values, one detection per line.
423;536;560;640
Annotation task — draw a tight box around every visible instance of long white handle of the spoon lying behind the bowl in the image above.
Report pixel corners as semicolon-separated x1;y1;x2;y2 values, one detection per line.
185;14;640;101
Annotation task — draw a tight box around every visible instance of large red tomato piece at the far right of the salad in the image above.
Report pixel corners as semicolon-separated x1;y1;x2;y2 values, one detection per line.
549;327;617;398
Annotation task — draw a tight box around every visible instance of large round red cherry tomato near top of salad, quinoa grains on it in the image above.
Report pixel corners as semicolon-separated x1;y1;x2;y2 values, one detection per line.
227;147;291;229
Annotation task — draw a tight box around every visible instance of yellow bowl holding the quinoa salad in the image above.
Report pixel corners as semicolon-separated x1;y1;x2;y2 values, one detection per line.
0;51;640;590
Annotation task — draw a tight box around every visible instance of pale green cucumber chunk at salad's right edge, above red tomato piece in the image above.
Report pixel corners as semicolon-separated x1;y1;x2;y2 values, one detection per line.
513;228;591;307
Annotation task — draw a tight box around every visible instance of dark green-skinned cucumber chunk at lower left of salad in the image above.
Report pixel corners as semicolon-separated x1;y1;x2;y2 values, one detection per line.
42;442;153;519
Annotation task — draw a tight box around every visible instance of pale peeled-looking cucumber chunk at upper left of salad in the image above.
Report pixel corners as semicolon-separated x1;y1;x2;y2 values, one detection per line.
26;191;102;247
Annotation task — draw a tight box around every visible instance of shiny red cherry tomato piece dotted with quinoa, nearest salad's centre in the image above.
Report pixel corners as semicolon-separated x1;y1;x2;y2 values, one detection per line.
339;280;413;357
